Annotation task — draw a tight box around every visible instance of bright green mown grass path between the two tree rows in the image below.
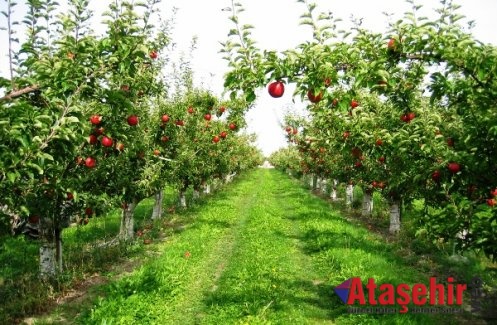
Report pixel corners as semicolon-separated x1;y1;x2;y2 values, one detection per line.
36;169;466;324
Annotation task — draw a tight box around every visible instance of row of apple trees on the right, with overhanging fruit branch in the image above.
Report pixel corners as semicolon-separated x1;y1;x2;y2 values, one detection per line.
224;1;497;258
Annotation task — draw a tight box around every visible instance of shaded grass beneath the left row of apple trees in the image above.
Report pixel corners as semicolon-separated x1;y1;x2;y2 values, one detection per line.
0;184;182;324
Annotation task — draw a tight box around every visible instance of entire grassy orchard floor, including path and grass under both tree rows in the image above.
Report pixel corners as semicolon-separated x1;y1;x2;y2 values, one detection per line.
0;170;495;324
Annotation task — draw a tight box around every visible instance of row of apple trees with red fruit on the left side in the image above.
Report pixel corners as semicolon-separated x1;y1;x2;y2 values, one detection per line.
0;0;261;275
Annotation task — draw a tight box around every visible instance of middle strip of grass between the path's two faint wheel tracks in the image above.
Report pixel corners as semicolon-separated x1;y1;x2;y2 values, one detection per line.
197;170;333;324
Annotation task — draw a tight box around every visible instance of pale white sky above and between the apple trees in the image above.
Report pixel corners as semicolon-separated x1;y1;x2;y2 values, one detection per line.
0;0;497;155
